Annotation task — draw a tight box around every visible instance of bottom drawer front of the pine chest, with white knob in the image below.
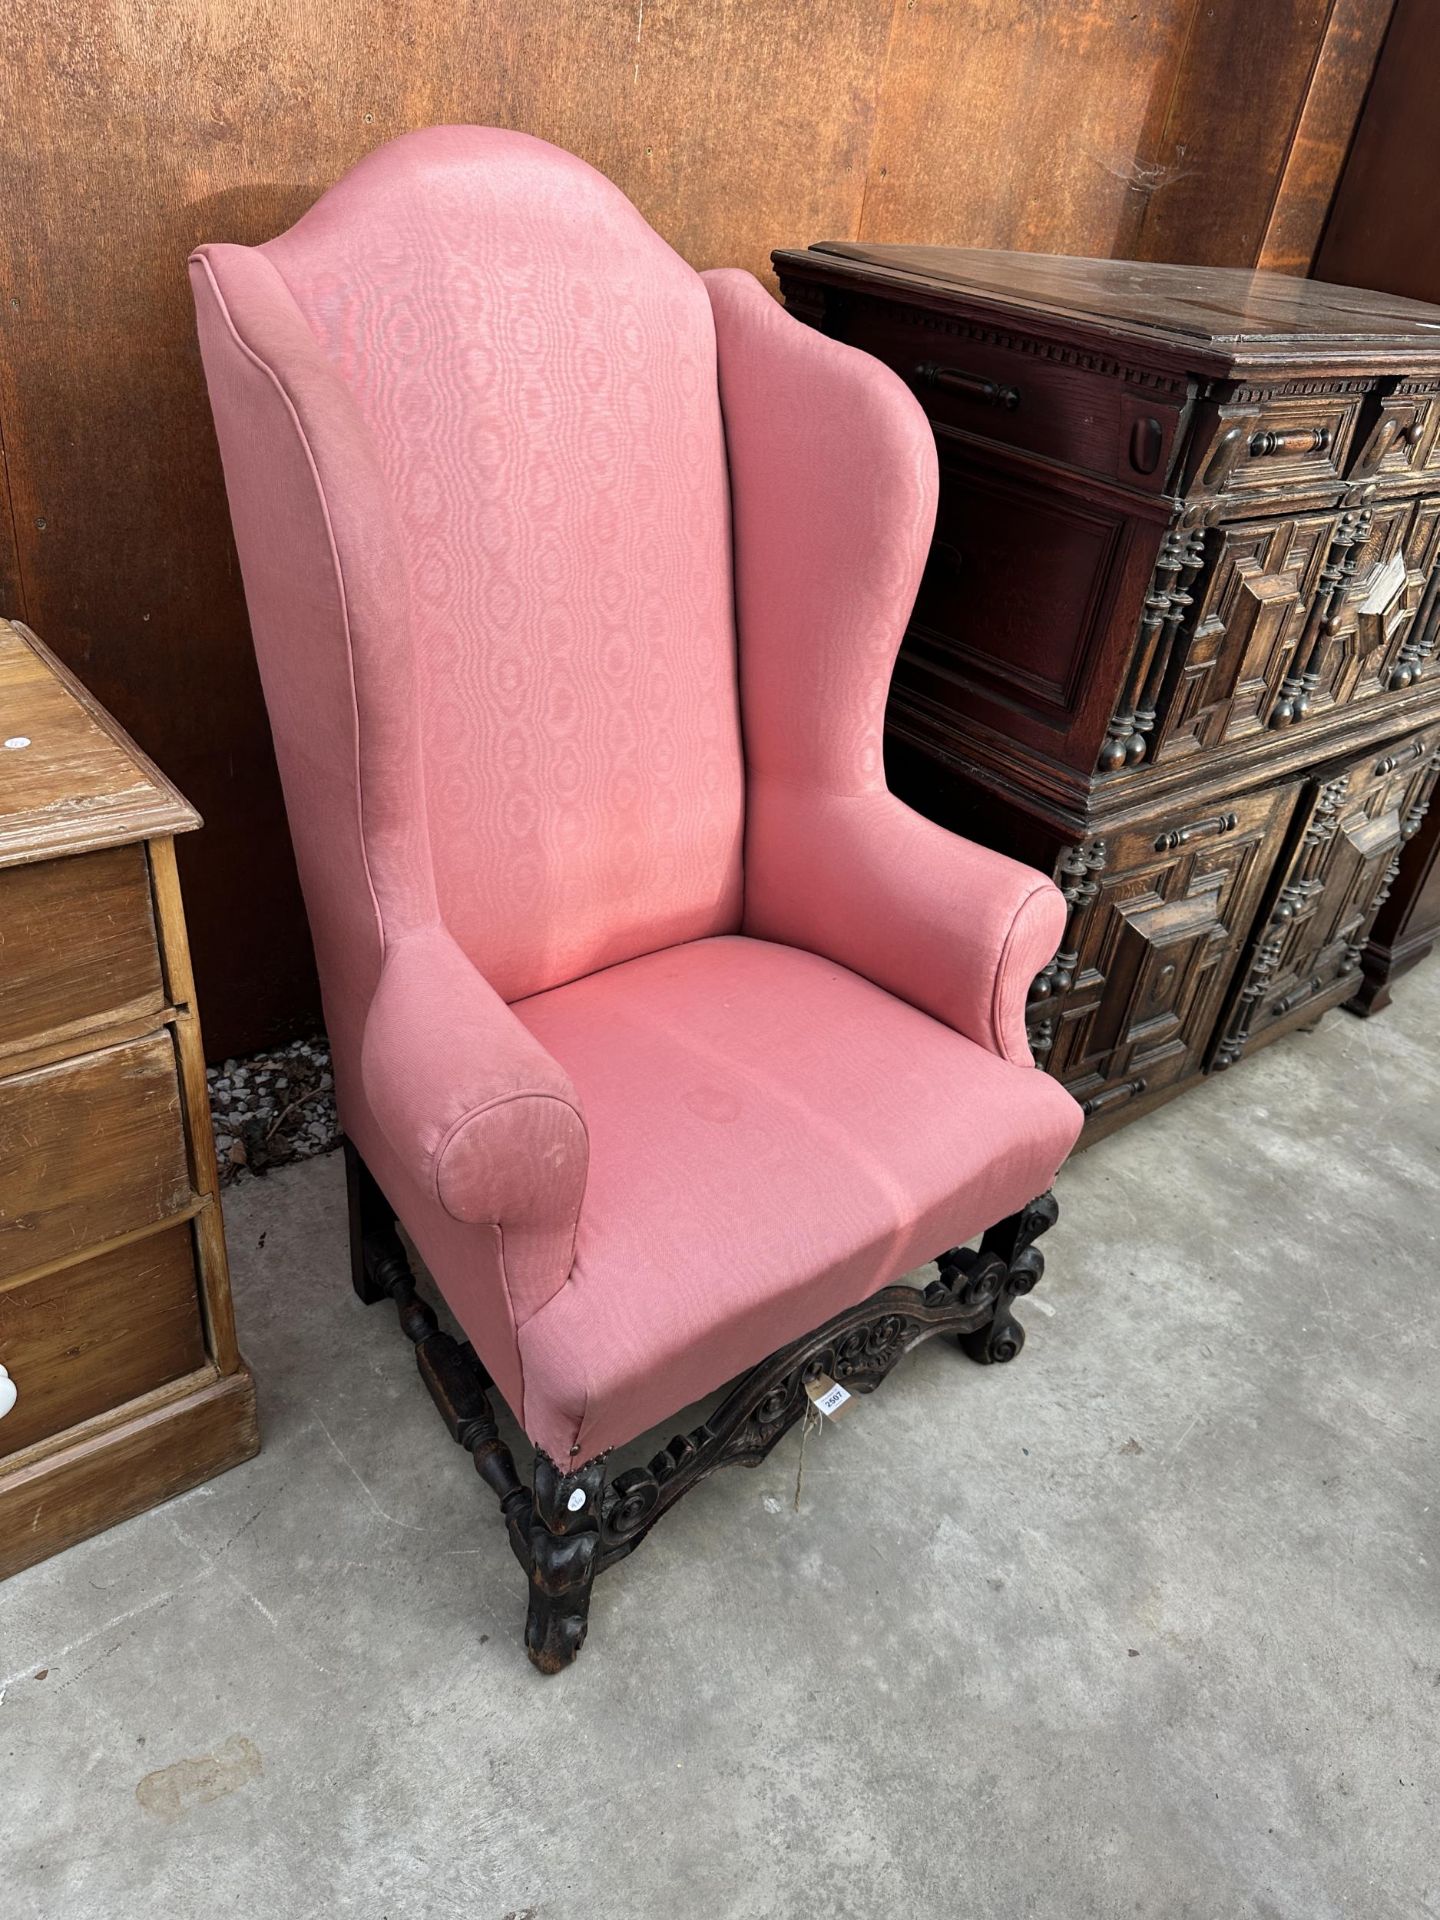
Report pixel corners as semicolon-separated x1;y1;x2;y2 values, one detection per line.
0;1223;205;1455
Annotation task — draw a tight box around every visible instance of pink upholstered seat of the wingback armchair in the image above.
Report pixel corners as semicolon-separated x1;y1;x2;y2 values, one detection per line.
515;935;1081;1461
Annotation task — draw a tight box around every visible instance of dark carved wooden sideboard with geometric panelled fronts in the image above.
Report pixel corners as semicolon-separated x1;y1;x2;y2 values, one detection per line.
774;244;1440;1139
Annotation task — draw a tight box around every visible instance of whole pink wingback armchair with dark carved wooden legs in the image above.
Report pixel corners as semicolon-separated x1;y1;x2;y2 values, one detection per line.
190;127;1081;1672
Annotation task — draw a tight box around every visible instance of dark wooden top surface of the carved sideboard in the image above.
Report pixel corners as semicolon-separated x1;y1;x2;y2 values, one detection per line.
772;240;1440;380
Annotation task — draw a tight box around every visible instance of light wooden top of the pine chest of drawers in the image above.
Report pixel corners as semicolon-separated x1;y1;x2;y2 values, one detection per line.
0;618;200;868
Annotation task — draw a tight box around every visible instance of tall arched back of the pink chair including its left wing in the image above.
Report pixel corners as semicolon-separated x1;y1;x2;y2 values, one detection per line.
194;127;743;1023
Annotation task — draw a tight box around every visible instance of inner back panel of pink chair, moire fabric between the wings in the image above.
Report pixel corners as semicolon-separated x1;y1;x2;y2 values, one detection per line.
261;127;743;998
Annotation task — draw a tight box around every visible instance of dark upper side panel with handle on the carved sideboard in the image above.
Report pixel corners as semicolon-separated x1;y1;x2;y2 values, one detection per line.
843;300;1185;493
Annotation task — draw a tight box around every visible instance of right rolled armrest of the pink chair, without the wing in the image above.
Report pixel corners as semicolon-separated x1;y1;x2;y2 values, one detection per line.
745;791;1066;1066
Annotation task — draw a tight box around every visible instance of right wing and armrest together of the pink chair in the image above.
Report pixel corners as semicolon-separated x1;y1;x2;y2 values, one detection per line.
705;271;1066;1064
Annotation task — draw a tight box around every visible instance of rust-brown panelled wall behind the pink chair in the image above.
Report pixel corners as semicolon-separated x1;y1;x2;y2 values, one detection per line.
0;0;1390;1056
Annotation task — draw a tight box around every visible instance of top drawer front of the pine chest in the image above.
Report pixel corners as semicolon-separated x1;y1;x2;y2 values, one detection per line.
0;847;165;1071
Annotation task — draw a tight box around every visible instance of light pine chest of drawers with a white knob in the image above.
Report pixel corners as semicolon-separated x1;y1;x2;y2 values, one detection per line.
0;620;259;1576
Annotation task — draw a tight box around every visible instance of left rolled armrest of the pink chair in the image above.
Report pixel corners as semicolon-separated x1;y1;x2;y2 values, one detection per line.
361;925;589;1228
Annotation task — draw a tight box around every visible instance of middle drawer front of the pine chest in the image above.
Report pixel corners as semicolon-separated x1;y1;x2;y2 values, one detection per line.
0;1029;190;1279
